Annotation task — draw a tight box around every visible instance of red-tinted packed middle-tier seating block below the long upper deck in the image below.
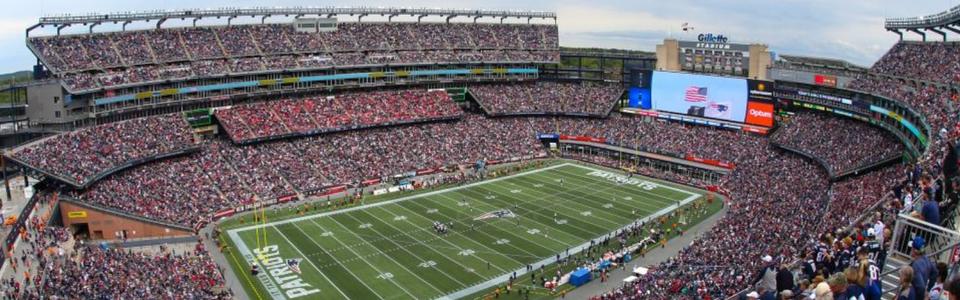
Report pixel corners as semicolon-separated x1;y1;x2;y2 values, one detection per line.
216;90;462;143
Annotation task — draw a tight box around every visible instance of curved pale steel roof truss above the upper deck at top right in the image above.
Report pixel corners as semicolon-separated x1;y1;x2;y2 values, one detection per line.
884;5;960;42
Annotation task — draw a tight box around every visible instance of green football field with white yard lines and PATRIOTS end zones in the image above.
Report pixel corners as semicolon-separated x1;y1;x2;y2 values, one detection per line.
226;163;704;299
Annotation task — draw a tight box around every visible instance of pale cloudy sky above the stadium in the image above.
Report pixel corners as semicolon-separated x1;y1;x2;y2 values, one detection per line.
0;0;958;73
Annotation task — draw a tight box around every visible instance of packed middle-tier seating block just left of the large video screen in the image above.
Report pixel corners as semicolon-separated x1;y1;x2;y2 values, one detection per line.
470;81;623;116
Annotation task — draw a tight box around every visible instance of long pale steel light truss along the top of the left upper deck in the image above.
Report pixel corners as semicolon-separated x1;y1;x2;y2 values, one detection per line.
26;7;557;37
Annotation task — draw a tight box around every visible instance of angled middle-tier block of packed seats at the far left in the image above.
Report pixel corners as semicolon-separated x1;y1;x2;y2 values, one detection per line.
11;114;196;186
